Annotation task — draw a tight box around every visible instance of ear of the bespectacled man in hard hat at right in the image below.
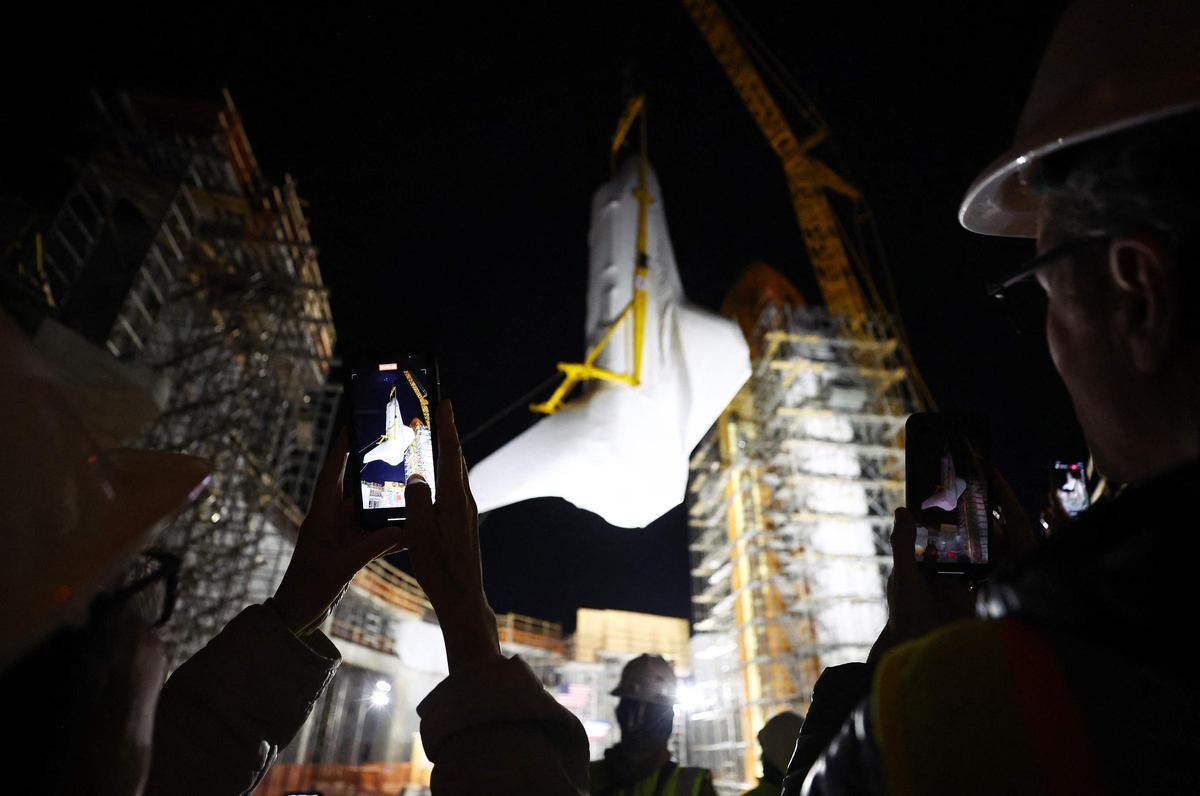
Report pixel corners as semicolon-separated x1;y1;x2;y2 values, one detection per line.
1109;235;1181;373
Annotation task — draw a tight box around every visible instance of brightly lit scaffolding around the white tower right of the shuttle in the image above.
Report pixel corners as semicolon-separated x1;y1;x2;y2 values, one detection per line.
689;305;916;789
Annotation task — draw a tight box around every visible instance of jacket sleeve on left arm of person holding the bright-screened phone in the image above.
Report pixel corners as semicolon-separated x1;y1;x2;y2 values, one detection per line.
144;605;341;796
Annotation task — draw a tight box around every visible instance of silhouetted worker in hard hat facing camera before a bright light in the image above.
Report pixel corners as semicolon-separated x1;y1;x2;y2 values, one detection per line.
590;654;716;796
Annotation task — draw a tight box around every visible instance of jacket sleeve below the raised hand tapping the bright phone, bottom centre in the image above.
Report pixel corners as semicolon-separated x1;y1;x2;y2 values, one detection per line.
416;657;588;796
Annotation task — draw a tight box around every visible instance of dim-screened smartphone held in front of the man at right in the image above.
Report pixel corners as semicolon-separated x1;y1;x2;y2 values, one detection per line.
905;412;991;577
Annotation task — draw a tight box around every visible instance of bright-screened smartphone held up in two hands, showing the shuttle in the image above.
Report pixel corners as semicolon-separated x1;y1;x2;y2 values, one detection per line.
344;353;440;528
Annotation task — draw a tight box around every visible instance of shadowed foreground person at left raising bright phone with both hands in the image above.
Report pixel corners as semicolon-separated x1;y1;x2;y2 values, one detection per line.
0;303;588;796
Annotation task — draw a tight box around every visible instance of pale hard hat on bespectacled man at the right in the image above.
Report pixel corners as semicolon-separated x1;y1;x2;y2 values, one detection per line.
959;0;1200;238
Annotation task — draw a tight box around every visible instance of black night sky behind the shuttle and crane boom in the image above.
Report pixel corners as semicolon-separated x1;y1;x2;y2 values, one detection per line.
7;0;1085;624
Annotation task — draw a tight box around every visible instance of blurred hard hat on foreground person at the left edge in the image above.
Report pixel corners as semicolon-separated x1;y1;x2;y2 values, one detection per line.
0;312;210;671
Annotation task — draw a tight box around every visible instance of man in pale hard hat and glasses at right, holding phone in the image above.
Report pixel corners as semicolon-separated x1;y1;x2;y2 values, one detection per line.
785;0;1200;794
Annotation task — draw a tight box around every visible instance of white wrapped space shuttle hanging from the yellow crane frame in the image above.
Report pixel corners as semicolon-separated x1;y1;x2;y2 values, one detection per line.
470;158;750;528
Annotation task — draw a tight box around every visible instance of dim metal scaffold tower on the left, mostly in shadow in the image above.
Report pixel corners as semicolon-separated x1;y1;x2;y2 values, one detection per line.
7;94;338;664
